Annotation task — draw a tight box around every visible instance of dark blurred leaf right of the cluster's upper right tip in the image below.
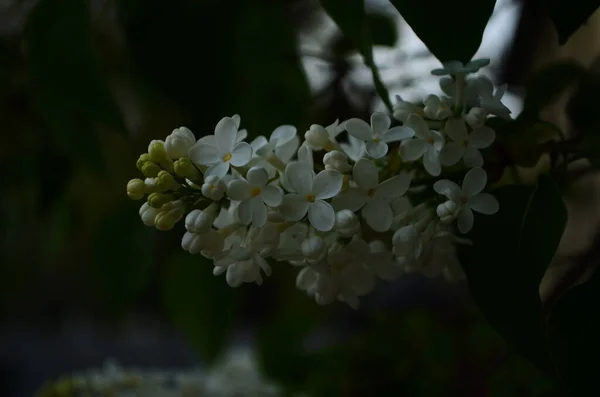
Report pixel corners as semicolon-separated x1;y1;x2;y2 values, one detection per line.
518;60;590;119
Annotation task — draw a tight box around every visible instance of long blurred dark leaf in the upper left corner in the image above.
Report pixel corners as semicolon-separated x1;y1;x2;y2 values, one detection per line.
26;0;125;172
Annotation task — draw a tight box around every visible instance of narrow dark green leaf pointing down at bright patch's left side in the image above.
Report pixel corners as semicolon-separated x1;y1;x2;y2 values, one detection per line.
321;0;392;112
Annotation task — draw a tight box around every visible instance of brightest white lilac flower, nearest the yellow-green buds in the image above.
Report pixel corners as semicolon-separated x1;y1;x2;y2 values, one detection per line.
188;117;252;177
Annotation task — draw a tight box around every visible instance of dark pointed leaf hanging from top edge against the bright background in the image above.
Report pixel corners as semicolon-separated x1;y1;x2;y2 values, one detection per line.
391;0;496;63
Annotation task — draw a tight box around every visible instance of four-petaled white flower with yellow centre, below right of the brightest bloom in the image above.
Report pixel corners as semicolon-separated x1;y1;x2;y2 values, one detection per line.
227;167;283;227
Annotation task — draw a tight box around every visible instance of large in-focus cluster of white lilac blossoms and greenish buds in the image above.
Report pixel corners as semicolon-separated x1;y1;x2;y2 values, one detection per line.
128;60;510;308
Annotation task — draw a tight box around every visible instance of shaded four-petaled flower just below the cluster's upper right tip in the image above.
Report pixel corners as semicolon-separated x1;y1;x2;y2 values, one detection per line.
439;119;496;167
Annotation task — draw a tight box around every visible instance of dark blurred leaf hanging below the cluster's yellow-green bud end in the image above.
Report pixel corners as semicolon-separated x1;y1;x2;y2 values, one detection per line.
162;250;239;365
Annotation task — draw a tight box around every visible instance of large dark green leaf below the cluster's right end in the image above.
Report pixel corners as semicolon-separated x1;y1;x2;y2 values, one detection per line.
461;175;567;373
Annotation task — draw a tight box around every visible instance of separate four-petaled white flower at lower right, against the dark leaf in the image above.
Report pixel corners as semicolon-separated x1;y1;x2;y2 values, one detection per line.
433;167;499;234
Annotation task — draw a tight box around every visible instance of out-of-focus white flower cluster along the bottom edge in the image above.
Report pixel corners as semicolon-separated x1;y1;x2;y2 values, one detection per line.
38;350;290;397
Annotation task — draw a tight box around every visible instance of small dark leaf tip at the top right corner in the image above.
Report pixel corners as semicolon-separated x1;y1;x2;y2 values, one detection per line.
546;0;598;45
